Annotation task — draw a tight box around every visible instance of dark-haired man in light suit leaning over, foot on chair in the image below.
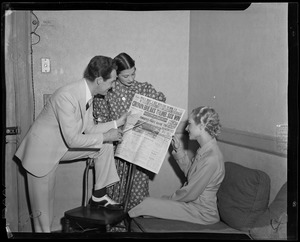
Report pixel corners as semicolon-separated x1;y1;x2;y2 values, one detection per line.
16;56;128;232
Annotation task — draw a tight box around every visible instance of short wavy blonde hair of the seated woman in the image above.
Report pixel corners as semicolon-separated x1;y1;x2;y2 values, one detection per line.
191;106;222;138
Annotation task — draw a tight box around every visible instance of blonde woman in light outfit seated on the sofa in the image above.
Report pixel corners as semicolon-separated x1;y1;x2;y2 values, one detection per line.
128;106;225;225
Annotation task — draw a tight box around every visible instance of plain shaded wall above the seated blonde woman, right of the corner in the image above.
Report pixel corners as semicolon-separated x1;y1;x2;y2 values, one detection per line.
188;3;288;136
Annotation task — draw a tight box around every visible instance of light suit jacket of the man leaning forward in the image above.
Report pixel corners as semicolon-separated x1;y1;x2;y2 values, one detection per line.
15;79;115;176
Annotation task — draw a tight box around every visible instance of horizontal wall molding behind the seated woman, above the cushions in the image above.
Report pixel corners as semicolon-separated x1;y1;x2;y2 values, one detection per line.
176;121;287;157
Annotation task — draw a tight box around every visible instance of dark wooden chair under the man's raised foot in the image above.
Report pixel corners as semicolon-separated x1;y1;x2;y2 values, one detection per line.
63;158;135;233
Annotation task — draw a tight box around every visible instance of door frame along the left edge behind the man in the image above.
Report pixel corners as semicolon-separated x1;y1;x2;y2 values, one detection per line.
5;10;34;232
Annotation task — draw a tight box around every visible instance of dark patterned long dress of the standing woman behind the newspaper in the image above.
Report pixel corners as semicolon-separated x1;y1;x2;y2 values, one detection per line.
93;81;166;231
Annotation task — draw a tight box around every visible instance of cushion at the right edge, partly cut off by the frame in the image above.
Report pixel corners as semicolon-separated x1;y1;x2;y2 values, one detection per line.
249;183;287;240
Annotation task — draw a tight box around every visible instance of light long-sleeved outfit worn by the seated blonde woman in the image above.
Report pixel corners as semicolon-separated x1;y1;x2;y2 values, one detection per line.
128;139;225;225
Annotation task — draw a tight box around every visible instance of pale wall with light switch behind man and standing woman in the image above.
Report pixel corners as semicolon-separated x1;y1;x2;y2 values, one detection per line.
33;10;189;118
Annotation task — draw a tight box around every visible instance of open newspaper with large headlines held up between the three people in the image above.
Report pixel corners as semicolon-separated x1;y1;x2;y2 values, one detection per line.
115;94;185;174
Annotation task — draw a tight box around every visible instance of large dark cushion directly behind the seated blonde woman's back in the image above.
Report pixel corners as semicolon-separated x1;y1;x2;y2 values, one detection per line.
217;161;270;231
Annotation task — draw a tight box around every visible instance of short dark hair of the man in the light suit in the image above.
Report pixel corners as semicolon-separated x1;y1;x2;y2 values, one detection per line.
83;55;118;81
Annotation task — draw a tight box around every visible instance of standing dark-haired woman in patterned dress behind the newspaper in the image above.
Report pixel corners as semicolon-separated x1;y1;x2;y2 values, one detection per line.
94;53;166;212
